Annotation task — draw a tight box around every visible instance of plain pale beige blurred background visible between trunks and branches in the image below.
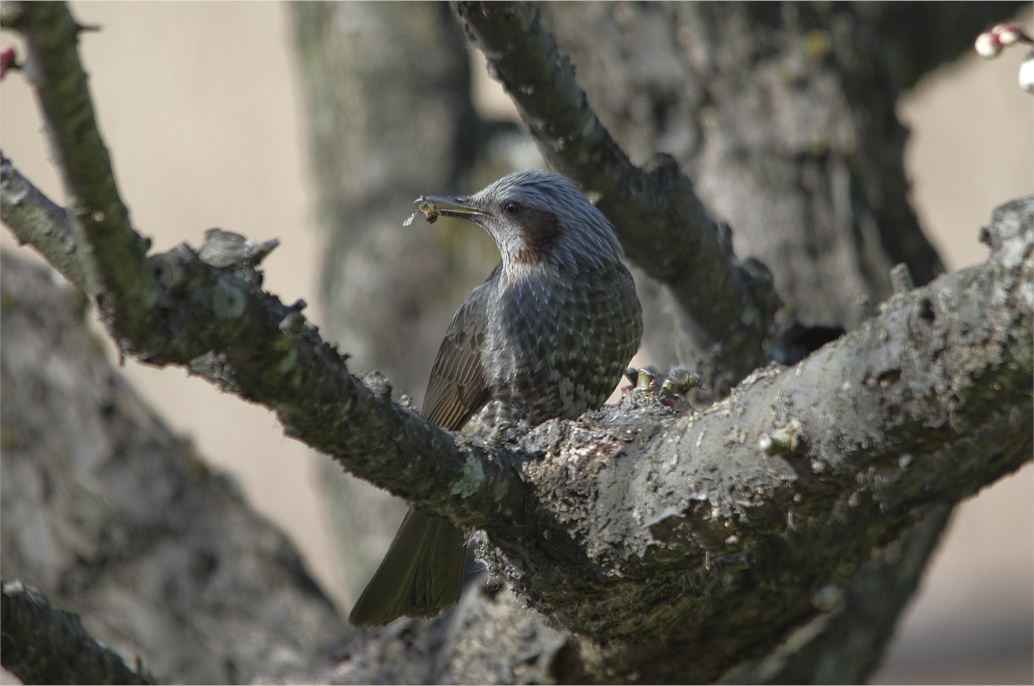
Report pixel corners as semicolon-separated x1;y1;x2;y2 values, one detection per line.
0;2;1034;683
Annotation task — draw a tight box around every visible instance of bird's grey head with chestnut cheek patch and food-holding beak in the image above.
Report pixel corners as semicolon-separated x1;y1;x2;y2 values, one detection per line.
418;169;624;275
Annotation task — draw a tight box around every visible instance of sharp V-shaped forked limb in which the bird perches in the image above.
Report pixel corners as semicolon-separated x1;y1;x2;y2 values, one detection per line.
4;4;1034;681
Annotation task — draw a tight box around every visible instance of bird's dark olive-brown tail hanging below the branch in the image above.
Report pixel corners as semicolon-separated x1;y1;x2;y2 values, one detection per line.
348;509;466;627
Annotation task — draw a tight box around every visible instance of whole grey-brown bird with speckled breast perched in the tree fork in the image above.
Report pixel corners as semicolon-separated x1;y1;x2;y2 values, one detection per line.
348;170;642;627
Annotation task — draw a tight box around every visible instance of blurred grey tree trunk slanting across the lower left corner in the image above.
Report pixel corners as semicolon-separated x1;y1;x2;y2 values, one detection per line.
0;257;346;683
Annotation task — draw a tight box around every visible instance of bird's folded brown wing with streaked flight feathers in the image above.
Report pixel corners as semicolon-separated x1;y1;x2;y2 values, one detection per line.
421;268;498;431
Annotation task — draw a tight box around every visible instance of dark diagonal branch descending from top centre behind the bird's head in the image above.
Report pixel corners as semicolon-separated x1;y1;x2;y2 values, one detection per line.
454;2;780;387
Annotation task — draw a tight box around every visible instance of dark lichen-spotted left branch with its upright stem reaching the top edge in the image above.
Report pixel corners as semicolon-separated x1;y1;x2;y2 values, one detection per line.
4;3;524;542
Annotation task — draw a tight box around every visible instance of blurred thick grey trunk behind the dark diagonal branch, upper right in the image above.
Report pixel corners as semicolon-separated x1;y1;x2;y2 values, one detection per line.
529;3;940;339
